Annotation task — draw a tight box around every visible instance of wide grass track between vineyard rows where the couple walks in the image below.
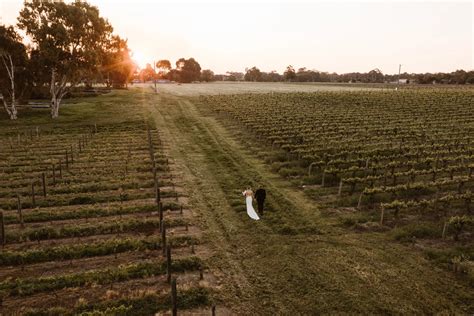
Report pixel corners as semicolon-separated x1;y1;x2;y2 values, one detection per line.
140;91;474;315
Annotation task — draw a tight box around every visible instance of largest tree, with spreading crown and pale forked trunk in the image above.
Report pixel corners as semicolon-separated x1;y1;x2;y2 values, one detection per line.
18;0;112;118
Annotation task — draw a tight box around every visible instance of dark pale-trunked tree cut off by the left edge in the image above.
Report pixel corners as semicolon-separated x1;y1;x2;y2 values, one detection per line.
0;25;28;120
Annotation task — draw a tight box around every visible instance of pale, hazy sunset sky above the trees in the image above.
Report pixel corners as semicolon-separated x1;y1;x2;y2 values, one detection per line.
0;0;474;74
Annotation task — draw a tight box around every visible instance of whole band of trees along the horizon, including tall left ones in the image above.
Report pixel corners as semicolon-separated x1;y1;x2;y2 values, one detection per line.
0;0;474;119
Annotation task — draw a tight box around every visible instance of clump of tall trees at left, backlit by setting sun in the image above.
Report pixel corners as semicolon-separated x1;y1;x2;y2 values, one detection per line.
0;0;136;119
